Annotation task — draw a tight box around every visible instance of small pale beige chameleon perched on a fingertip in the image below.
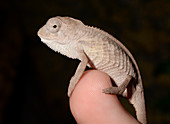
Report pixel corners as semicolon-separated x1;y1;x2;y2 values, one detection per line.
38;16;147;124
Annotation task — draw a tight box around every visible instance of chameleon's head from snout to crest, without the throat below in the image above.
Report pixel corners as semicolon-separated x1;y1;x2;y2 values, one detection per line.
38;16;83;44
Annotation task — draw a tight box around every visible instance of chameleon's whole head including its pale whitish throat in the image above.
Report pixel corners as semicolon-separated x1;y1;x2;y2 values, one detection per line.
38;16;84;58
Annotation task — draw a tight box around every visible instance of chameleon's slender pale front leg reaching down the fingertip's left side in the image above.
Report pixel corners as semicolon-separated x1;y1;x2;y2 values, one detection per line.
67;51;88;97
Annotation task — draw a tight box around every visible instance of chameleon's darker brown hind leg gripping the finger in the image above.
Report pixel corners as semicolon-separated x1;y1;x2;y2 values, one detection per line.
103;75;132;97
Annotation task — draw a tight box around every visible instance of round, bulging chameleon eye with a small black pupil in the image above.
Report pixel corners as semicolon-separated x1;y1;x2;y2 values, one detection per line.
46;18;61;33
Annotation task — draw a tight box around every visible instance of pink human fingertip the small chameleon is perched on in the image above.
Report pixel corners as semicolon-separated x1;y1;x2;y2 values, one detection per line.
70;70;139;124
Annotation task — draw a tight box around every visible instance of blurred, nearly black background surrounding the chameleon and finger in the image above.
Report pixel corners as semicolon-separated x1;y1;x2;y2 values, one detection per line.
0;0;170;124
